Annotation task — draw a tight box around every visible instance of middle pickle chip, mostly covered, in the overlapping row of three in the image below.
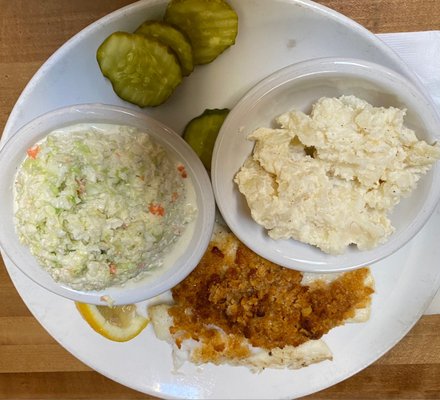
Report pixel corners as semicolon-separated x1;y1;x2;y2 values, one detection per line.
134;21;194;76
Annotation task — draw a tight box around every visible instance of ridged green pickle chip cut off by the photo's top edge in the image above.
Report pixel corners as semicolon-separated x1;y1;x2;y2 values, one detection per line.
164;0;238;64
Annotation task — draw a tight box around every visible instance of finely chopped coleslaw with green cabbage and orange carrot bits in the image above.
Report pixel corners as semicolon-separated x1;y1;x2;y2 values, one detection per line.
15;125;196;290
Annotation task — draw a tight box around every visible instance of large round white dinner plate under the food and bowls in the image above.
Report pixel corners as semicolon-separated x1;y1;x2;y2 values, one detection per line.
3;0;440;399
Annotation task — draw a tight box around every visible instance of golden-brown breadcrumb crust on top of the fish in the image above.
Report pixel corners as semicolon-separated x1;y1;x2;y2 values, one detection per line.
169;236;373;362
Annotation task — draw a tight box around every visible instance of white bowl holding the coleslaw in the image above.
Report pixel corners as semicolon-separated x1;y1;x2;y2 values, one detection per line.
0;104;215;304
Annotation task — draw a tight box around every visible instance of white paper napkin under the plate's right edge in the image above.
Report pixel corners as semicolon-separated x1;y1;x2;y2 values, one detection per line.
378;31;440;314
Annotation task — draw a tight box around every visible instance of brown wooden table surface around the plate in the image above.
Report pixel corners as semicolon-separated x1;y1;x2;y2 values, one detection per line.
0;0;440;399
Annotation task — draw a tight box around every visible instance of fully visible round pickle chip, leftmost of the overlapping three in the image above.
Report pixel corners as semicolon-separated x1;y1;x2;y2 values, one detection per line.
96;32;182;107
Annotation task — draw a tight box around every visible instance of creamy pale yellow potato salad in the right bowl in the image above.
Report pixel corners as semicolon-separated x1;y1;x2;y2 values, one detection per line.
235;96;440;254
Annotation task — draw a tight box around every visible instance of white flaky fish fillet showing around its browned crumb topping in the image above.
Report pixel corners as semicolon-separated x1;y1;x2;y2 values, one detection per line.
148;225;374;372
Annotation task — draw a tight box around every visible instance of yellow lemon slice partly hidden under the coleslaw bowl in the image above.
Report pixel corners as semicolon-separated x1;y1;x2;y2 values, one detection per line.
75;302;149;342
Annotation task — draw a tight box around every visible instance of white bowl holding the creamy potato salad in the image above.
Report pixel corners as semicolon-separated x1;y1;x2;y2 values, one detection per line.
211;58;440;272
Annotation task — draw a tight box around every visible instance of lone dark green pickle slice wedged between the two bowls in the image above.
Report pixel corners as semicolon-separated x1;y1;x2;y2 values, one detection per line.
183;108;229;171
